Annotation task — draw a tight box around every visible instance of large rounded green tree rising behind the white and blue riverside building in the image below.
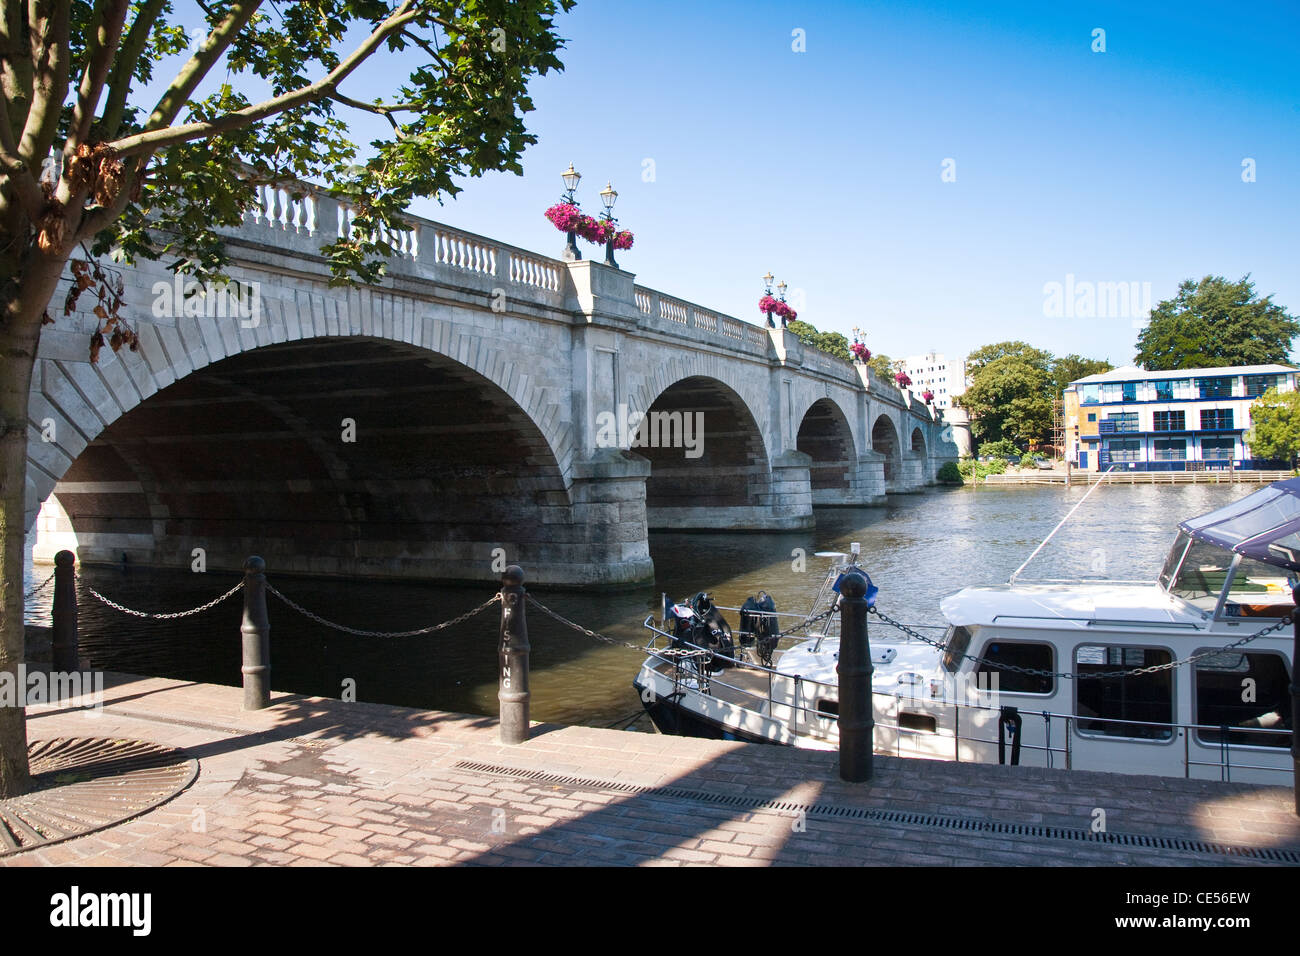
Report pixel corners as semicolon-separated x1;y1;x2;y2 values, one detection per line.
1134;274;1300;372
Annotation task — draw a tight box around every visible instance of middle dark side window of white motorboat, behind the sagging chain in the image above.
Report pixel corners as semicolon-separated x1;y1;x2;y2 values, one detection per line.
1074;645;1174;740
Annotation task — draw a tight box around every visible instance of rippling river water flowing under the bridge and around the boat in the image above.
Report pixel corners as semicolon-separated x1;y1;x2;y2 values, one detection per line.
25;484;1258;730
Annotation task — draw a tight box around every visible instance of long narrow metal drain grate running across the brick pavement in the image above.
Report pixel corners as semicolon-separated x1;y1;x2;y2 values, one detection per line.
454;761;1300;864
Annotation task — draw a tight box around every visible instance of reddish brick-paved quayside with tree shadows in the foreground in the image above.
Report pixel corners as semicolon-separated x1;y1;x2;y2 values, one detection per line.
0;675;1300;866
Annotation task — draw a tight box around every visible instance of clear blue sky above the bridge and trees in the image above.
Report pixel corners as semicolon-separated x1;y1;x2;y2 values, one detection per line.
144;0;1300;364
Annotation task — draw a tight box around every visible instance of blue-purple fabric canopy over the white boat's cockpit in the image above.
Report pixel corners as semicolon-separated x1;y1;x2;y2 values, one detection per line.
1178;479;1300;571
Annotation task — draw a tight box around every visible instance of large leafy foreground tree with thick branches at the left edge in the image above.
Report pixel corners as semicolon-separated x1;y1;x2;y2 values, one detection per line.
0;0;573;797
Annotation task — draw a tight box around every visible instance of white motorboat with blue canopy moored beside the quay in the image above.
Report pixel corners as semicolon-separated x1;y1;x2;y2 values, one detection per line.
634;479;1300;784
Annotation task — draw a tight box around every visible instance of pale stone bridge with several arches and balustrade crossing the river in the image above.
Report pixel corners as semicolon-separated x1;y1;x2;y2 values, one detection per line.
20;180;957;584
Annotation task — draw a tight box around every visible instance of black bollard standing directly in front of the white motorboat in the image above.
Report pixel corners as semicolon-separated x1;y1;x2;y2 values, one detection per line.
835;571;875;783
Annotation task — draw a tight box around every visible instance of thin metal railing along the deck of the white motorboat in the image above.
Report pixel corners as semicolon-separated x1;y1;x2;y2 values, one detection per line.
645;615;1292;782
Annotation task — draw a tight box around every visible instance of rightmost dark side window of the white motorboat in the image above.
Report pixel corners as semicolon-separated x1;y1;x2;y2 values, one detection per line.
1195;650;1292;749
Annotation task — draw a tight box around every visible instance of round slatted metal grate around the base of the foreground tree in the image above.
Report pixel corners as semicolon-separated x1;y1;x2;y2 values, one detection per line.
0;737;199;856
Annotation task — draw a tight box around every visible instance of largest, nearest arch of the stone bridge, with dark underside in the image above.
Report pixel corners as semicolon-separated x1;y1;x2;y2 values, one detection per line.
29;314;653;583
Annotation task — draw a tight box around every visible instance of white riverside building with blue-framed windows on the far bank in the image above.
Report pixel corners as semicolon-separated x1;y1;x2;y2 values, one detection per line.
1063;365;1297;471
